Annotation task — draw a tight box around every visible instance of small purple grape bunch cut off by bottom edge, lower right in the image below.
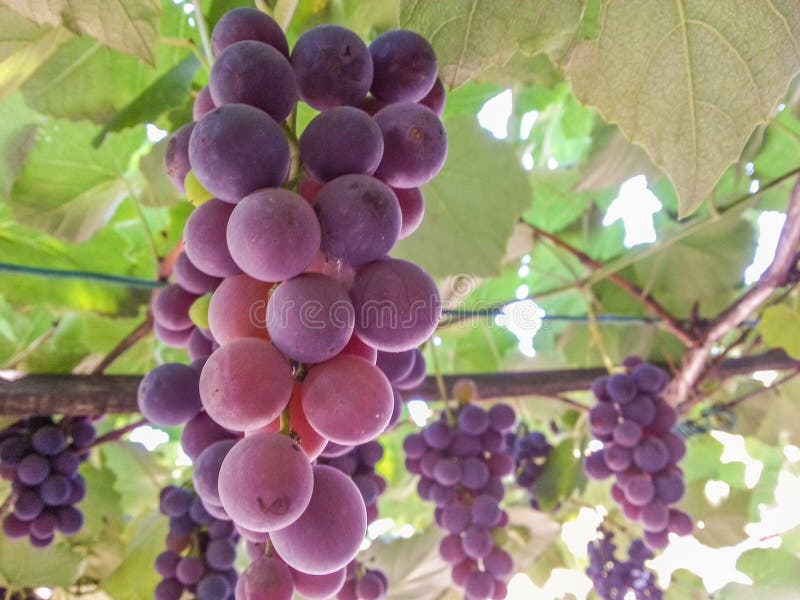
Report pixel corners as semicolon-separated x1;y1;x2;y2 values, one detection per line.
586;528;664;600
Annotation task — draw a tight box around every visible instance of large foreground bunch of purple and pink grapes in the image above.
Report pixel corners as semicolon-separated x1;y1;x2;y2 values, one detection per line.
139;9;447;598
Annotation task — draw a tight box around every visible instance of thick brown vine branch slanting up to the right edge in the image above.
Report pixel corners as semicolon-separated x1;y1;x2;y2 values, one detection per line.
668;179;800;406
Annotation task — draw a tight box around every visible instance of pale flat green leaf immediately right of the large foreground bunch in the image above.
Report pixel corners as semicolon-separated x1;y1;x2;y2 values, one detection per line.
392;116;530;277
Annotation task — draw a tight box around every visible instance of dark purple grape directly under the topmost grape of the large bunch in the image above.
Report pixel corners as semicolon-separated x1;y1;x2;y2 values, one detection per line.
208;40;297;121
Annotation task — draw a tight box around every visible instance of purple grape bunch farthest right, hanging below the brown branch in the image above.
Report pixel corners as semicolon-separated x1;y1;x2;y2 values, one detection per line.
584;358;692;550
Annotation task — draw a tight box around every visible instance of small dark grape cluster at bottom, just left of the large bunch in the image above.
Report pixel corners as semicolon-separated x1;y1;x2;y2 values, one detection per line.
155;486;239;600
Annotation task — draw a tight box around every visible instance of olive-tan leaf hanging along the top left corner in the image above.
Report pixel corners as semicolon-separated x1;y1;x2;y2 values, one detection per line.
6;0;161;64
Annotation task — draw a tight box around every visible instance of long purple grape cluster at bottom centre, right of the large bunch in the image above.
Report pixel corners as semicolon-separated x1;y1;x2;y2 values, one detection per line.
403;390;516;600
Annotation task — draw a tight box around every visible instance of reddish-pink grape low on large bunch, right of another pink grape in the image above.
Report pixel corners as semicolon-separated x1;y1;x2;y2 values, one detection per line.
303;354;393;445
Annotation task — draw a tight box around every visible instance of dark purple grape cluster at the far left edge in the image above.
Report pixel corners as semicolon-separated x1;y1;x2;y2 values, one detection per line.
0;417;95;548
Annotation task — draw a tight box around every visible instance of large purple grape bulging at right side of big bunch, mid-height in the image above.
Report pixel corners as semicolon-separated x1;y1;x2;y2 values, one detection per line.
350;258;442;352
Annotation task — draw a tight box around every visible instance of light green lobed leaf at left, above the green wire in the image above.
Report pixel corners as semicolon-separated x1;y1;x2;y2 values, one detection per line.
11;121;144;242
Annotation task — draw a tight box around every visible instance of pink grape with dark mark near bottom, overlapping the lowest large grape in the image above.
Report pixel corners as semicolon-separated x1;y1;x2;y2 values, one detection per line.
219;433;316;528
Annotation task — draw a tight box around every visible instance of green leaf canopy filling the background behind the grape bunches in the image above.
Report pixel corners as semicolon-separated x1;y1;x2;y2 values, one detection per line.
0;0;800;600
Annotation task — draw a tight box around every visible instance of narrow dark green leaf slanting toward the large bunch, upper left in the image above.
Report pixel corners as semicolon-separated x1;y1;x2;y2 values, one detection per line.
92;54;200;148
